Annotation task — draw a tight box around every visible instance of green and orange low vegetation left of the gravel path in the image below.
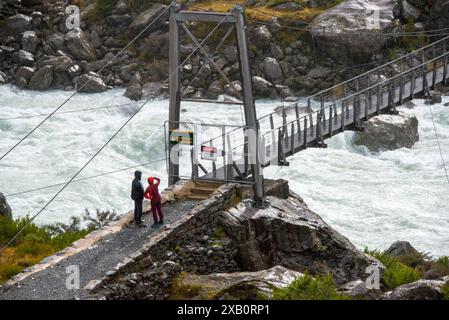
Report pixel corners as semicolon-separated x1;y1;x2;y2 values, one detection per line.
0;210;117;284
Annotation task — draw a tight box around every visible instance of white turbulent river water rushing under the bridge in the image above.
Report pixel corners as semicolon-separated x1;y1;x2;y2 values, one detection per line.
0;86;449;255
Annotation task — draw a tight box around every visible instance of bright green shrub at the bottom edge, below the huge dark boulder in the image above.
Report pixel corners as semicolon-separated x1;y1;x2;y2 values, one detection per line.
271;274;350;300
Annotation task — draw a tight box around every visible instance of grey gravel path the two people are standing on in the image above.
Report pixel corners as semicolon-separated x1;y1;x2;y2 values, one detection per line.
0;201;197;300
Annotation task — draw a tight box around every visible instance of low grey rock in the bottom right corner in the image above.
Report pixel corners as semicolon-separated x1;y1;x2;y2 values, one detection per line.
382;280;445;300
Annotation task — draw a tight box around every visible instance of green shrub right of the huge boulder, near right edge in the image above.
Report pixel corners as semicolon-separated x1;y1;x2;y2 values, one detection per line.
365;248;422;289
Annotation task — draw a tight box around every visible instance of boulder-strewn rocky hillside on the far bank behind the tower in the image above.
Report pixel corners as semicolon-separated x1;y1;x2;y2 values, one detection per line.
0;0;449;99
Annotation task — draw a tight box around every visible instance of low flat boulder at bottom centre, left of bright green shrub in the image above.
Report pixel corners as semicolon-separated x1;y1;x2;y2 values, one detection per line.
174;266;303;300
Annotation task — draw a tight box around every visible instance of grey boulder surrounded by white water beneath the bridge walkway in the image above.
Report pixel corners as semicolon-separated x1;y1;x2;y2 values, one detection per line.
353;112;419;152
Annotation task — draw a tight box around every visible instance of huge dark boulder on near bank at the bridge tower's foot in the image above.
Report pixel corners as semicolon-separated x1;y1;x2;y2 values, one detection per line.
221;194;383;284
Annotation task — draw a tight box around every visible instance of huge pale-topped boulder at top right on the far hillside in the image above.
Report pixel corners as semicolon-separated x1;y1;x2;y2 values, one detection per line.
309;0;396;64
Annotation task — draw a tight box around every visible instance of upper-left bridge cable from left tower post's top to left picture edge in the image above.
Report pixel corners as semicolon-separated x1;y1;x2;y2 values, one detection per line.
0;4;172;161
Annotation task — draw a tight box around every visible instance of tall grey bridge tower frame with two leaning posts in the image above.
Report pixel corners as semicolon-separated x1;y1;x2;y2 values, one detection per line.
168;2;264;206
